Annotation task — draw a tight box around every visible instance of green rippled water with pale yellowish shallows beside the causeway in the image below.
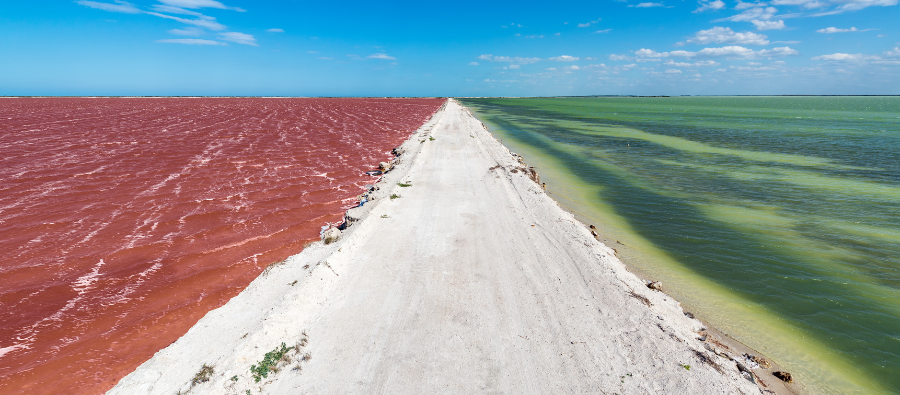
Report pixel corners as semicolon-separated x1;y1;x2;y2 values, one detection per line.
461;97;900;394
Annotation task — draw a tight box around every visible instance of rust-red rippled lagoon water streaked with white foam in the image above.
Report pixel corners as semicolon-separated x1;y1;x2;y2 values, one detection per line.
0;98;443;394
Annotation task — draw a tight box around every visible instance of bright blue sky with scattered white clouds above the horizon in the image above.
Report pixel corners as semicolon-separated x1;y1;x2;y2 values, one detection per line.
0;0;900;96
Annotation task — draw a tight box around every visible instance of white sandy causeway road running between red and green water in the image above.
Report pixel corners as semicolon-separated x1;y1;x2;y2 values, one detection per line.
110;100;760;395
